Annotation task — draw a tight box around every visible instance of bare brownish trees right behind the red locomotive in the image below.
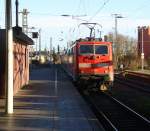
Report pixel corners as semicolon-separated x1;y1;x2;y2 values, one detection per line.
108;33;139;69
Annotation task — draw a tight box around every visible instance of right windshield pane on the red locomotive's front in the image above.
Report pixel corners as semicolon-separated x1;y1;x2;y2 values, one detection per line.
95;45;108;54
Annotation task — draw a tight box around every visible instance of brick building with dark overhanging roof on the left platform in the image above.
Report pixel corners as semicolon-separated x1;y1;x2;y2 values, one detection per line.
0;27;33;97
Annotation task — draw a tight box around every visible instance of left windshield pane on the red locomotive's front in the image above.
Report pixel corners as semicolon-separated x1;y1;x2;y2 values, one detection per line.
80;45;94;54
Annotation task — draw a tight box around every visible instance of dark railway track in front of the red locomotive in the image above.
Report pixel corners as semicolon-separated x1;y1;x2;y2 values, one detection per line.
82;92;150;131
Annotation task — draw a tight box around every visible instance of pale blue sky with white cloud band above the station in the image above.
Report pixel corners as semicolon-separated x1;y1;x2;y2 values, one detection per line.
0;0;150;48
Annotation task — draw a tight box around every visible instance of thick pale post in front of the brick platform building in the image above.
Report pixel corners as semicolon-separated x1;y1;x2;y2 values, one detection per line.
5;0;13;114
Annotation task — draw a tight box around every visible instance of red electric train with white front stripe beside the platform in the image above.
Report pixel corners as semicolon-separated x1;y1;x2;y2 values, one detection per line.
63;23;114;90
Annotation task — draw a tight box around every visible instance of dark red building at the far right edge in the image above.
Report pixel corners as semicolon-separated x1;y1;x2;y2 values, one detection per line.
138;26;150;59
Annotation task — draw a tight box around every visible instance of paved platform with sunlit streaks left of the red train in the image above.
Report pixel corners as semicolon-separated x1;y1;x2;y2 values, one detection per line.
0;66;104;131
